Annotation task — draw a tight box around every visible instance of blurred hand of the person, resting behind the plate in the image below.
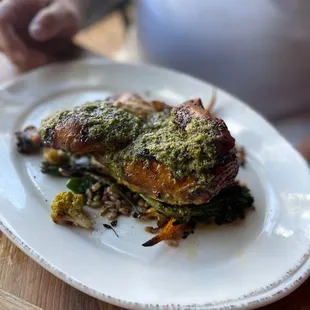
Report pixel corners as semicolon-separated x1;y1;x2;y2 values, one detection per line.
0;0;81;70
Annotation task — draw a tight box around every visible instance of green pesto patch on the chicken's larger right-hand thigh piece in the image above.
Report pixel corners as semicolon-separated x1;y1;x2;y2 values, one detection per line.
110;113;216;187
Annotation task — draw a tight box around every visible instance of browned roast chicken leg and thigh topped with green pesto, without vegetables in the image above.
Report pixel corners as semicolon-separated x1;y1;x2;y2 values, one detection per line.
40;94;239;205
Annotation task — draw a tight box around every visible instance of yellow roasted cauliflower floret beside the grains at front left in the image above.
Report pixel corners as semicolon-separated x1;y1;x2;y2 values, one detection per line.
51;192;93;229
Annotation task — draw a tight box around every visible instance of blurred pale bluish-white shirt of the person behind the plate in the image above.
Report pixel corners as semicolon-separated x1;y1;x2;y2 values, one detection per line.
137;0;310;144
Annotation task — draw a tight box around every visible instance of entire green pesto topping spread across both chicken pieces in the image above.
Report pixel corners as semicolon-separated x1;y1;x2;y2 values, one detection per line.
41;101;218;187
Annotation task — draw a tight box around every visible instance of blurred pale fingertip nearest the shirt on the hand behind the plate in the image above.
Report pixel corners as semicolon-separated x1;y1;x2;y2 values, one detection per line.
29;2;78;41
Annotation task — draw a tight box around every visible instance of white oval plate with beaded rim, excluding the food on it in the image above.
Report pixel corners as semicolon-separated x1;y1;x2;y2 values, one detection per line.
0;60;310;309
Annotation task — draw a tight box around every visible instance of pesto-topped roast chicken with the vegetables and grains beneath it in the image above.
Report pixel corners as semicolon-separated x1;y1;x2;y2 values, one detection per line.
17;93;254;247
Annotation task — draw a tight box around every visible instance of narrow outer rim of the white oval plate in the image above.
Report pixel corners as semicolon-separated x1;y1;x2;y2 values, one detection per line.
0;57;310;310
